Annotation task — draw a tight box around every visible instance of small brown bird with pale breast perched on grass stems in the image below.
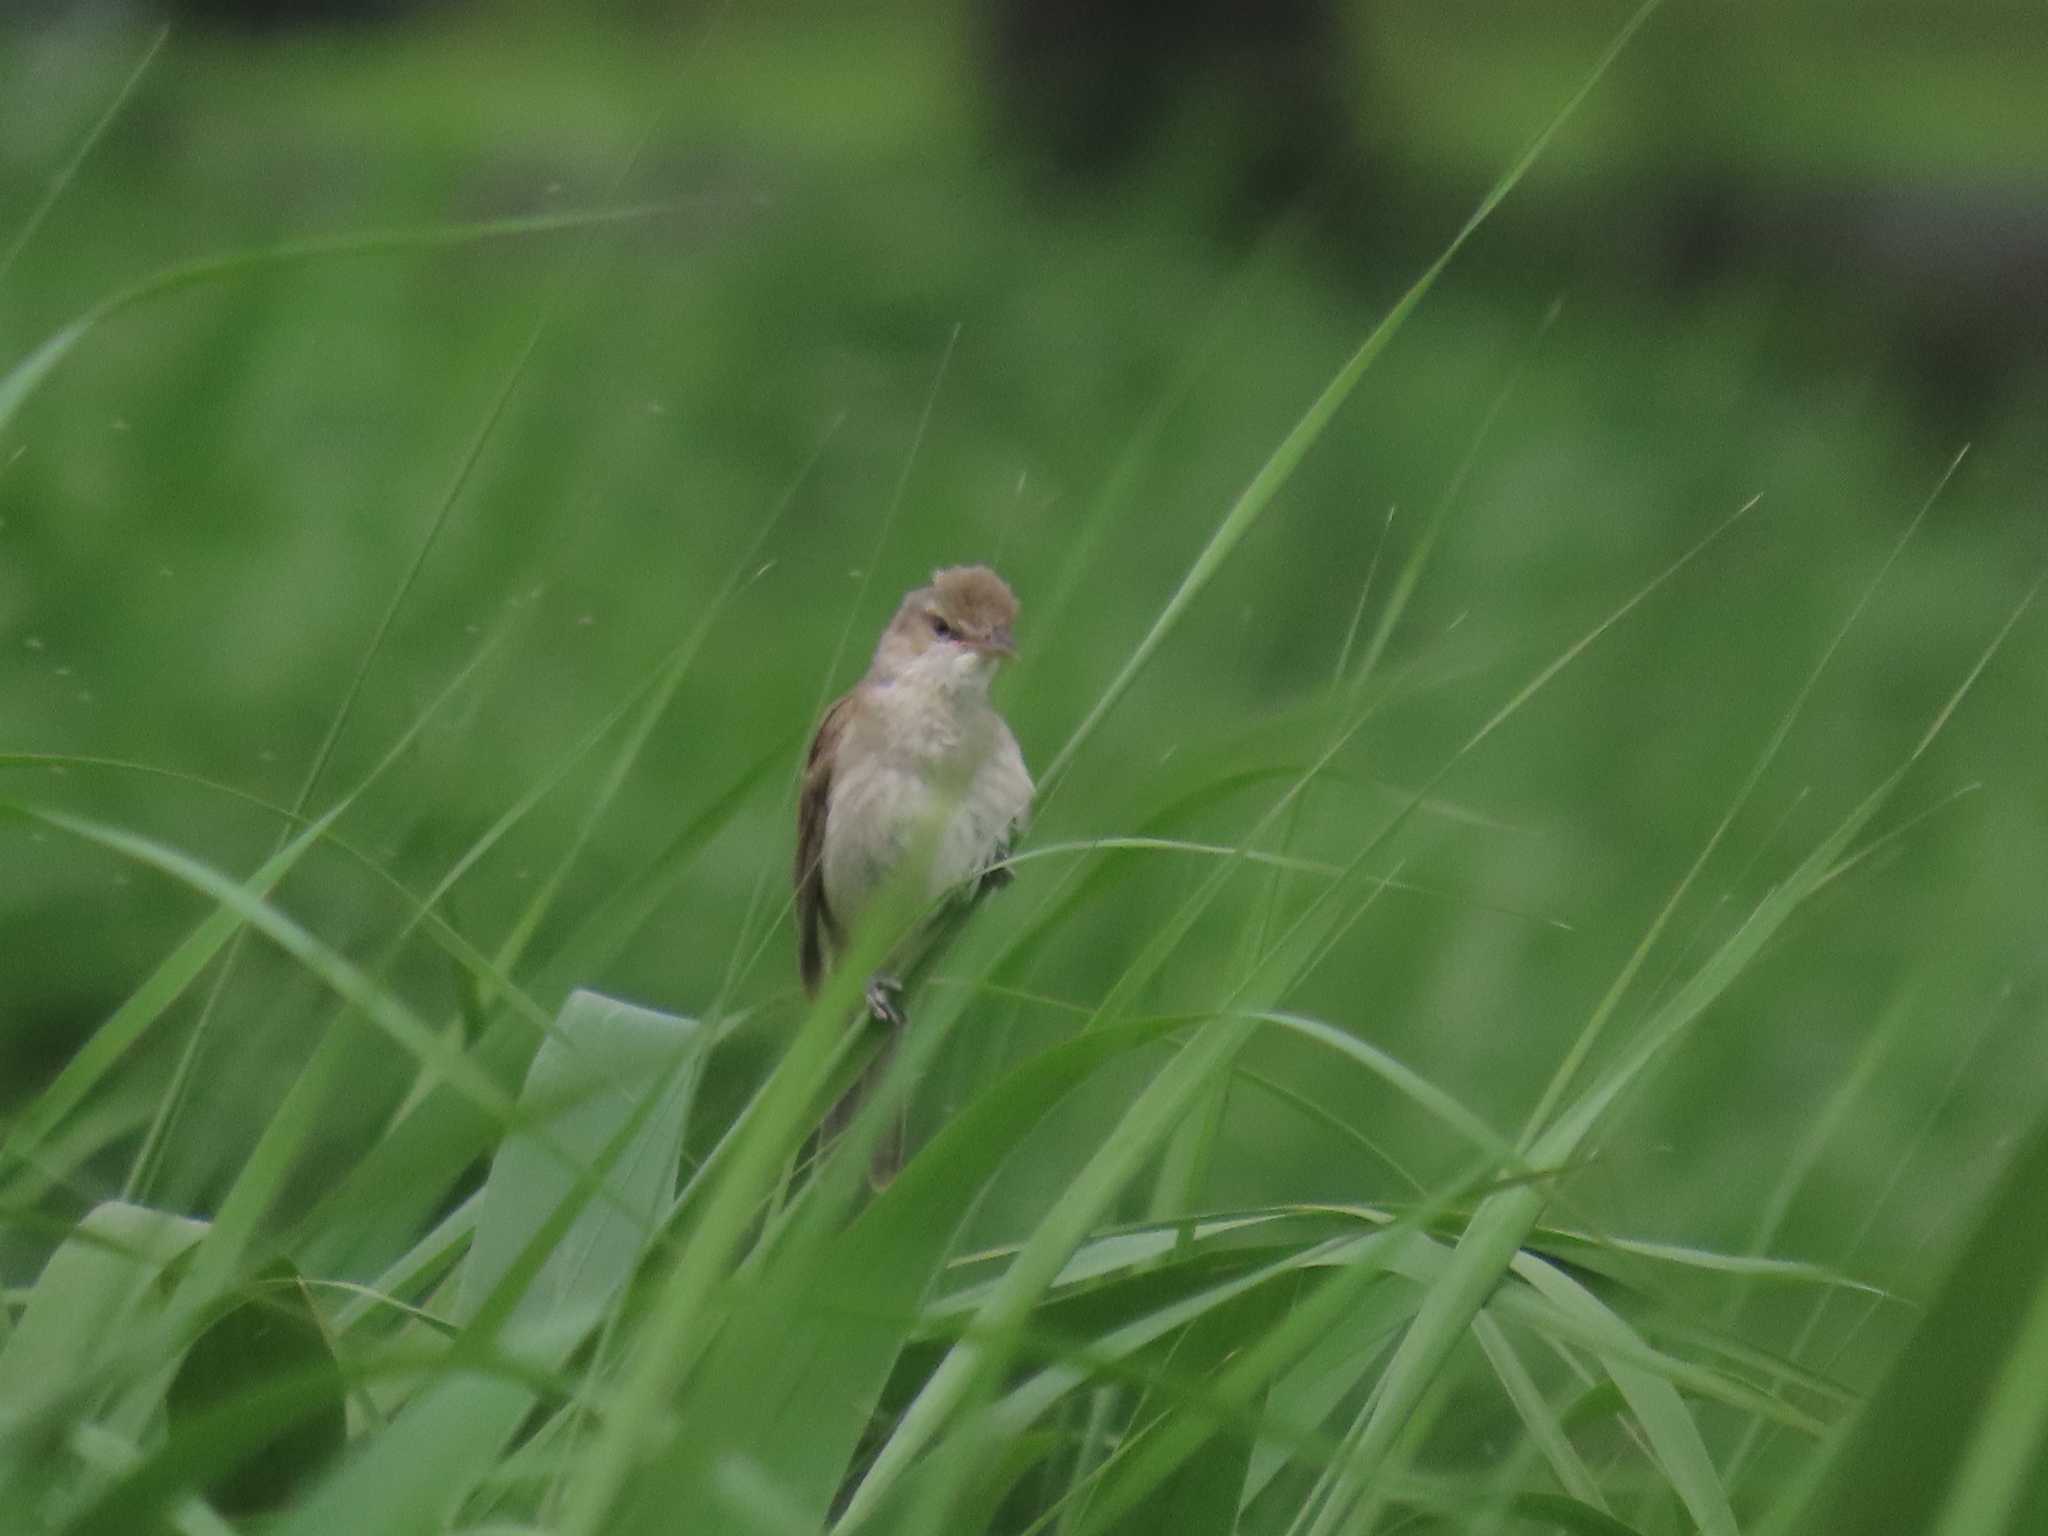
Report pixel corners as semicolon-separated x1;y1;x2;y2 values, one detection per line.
795;565;1032;1188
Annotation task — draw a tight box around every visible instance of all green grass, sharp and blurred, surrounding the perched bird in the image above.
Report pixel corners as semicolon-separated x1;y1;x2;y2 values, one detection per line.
0;6;2048;1536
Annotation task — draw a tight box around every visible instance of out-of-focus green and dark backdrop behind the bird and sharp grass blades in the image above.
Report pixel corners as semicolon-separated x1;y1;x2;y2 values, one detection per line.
0;0;2048;1417
